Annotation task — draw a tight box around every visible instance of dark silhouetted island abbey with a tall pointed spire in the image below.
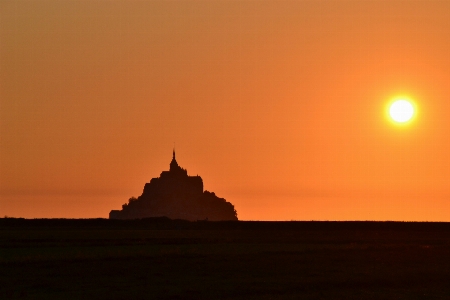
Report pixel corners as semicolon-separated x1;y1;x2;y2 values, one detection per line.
109;150;238;221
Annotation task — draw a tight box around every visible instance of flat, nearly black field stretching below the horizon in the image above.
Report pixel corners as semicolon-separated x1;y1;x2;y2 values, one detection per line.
0;219;450;299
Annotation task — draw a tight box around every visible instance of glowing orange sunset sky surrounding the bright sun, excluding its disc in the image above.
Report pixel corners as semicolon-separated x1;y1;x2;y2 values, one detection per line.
0;0;450;221
